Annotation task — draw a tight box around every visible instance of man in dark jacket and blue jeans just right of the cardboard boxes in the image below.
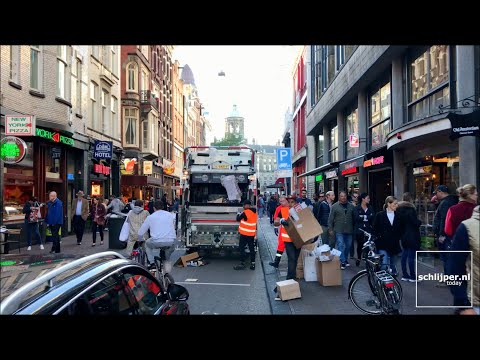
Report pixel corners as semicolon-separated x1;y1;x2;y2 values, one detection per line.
328;191;355;270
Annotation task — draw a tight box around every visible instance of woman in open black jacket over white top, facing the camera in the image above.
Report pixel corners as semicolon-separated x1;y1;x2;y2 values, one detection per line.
373;196;403;276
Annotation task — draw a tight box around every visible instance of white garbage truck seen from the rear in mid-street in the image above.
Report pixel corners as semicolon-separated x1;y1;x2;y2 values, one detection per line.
181;146;256;254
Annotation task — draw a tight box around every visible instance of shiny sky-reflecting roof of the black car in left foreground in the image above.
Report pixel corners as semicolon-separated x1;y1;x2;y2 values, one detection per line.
0;251;131;315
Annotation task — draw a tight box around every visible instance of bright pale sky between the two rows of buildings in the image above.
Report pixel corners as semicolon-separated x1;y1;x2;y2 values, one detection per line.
173;46;302;145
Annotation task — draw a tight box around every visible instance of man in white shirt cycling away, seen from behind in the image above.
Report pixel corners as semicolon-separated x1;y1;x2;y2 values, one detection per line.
138;200;177;272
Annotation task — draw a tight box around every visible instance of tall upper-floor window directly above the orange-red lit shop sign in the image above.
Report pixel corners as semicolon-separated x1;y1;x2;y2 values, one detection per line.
369;82;391;148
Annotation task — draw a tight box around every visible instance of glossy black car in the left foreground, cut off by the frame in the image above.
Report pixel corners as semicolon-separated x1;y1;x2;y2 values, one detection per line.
0;251;190;315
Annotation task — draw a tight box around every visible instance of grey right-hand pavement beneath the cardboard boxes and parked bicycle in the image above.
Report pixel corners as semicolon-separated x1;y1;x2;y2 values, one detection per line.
257;218;453;315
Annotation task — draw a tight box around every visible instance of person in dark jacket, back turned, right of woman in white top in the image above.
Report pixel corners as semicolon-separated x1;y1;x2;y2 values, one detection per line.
397;193;422;282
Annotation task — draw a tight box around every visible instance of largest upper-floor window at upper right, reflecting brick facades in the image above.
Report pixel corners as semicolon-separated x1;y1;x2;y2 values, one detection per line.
408;45;450;121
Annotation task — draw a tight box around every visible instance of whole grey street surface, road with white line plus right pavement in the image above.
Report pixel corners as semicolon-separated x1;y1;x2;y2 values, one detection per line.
0;217;458;315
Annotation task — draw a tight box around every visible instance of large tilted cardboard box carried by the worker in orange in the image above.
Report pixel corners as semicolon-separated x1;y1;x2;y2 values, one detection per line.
285;207;322;249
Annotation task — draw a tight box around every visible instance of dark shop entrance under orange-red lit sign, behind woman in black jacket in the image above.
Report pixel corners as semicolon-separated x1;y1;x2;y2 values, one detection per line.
363;147;394;212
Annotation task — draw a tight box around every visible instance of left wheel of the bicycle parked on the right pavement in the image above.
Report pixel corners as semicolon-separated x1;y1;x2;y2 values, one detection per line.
348;270;382;315
